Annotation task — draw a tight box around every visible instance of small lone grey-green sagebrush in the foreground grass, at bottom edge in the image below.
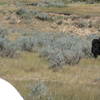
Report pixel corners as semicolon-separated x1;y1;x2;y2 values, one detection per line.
30;80;54;100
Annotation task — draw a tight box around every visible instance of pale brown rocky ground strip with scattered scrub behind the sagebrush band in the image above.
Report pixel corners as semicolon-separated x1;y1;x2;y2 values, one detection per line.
0;5;100;36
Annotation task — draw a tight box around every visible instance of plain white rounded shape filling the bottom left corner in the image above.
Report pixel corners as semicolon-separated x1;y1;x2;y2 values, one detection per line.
0;78;24;100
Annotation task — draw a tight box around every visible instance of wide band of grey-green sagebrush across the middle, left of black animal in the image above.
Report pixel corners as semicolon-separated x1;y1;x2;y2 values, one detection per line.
0;31;97;67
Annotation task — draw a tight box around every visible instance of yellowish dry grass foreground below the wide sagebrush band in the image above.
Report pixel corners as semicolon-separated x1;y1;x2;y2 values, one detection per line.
0;52;100;100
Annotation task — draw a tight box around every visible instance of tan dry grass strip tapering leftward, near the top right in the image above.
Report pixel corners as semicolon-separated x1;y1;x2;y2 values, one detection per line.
42;4;100;16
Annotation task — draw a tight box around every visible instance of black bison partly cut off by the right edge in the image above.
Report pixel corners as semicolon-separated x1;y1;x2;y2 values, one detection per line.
91;38;100;58
